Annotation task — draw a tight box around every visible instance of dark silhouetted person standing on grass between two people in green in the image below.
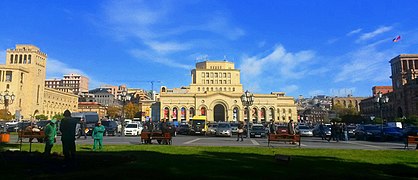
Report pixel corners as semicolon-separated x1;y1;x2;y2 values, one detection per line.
60;110;77;163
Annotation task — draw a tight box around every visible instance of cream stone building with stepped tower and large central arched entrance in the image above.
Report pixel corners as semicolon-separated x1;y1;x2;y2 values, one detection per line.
159;61;297;123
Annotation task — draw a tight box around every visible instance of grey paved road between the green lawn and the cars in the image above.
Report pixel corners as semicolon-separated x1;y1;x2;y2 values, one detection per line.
10;135;404;150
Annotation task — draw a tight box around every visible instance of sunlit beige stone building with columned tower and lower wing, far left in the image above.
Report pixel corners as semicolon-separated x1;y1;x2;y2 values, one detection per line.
0;44;77;119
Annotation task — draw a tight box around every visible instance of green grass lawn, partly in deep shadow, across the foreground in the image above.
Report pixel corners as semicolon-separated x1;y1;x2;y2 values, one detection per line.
2;143;418;179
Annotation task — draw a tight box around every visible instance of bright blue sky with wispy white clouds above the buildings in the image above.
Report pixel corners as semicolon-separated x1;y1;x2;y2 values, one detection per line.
0;0;418;97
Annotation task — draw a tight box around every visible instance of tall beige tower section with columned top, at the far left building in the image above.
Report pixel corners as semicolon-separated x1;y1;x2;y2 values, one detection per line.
0;44;47;119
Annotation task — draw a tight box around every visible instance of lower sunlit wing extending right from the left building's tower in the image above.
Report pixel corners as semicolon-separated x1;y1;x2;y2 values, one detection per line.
41;88;78;118
